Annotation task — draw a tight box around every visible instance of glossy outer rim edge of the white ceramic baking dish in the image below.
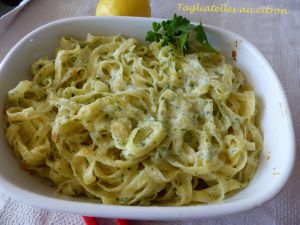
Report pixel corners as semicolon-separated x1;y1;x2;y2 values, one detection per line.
0;16;296;220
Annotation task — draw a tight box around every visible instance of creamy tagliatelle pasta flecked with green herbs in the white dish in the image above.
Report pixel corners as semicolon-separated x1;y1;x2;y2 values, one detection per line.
5;34;262;206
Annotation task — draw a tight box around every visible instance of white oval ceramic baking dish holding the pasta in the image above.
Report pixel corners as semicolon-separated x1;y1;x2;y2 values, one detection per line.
0;17;295;220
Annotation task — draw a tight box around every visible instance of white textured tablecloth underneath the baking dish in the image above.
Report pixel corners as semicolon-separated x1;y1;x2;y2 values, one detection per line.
0;0;300;225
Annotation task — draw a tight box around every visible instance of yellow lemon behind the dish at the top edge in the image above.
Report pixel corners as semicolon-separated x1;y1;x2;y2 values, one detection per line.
96;0;151;17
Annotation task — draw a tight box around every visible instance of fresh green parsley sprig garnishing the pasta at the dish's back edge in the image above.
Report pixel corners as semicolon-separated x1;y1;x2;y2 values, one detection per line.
146;14;217;55
